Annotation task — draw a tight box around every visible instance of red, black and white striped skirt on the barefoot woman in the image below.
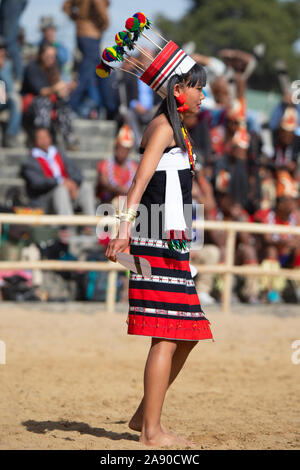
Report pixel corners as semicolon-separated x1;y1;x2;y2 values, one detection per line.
127;237;213;341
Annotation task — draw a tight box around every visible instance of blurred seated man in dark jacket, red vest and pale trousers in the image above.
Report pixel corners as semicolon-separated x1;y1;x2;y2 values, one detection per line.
21;128;96;224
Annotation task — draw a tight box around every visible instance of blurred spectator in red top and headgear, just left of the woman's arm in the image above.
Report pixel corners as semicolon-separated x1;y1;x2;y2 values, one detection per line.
96;124;137;202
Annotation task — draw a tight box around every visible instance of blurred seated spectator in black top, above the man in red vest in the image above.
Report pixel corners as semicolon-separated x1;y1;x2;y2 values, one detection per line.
22;44;78;150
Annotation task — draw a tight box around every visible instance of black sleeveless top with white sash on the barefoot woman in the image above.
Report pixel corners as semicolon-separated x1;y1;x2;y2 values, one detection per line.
136;147;192;239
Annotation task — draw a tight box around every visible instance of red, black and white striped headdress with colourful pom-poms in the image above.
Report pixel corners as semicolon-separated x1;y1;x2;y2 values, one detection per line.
96;12;195;98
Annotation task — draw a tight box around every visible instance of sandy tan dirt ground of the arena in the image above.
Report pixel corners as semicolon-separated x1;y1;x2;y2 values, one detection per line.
0;302;300;449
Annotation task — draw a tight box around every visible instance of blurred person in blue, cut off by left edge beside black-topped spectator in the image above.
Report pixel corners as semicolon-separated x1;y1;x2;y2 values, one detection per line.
0;38;21;147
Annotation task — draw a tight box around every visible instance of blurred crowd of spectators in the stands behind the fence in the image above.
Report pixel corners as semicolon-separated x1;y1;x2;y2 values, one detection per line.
0;0;300;305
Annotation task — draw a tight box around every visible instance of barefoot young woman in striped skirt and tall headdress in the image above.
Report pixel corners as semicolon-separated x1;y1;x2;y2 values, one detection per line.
105;14;213;446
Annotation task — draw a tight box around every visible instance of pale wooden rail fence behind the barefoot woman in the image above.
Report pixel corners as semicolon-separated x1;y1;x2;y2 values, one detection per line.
0;213;300;313
